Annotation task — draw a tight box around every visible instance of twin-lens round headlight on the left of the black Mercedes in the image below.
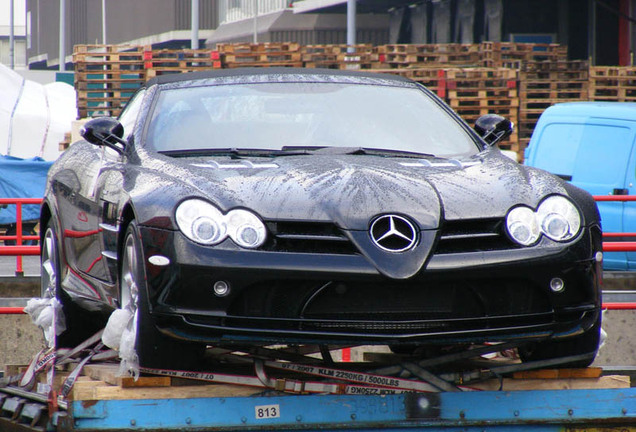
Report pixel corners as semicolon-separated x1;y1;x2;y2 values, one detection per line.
176;199;267;248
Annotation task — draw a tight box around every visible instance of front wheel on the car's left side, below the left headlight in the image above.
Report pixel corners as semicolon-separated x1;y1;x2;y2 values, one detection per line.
119;221;205;370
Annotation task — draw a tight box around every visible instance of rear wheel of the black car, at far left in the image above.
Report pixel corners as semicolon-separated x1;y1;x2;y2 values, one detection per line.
40;220;101;348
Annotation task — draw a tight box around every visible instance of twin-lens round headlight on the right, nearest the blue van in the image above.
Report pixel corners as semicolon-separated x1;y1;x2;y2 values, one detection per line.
506;195;581;246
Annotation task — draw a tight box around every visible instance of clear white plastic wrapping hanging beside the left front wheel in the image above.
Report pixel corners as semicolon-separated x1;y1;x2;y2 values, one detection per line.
102;308;139;379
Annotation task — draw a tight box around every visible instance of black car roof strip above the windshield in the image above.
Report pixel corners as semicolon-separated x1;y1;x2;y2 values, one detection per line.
146;67;420;87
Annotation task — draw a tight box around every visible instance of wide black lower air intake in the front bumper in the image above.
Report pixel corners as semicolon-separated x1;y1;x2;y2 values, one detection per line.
219;279;553;335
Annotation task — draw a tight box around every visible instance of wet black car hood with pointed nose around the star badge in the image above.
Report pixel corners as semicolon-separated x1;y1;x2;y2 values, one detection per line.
142;150;567;278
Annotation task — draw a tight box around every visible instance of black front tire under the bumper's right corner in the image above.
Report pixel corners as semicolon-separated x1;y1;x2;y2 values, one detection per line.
519;311;601;368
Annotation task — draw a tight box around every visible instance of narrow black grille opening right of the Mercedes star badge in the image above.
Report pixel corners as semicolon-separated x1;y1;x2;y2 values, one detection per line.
435;218;520;254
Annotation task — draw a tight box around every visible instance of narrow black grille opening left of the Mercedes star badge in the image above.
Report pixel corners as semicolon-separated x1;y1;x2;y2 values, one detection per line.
262;221;357;255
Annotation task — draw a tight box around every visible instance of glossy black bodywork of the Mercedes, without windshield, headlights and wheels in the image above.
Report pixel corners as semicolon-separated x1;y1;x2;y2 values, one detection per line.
43;70;601;350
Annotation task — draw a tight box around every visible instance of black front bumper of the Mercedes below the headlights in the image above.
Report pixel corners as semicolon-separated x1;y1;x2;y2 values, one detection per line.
141;227;601;344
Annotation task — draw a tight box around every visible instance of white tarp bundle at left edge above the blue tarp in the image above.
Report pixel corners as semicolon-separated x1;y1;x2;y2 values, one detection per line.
0;64;77;161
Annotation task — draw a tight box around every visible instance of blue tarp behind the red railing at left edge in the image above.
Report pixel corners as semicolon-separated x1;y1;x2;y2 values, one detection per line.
0;155;53;225
